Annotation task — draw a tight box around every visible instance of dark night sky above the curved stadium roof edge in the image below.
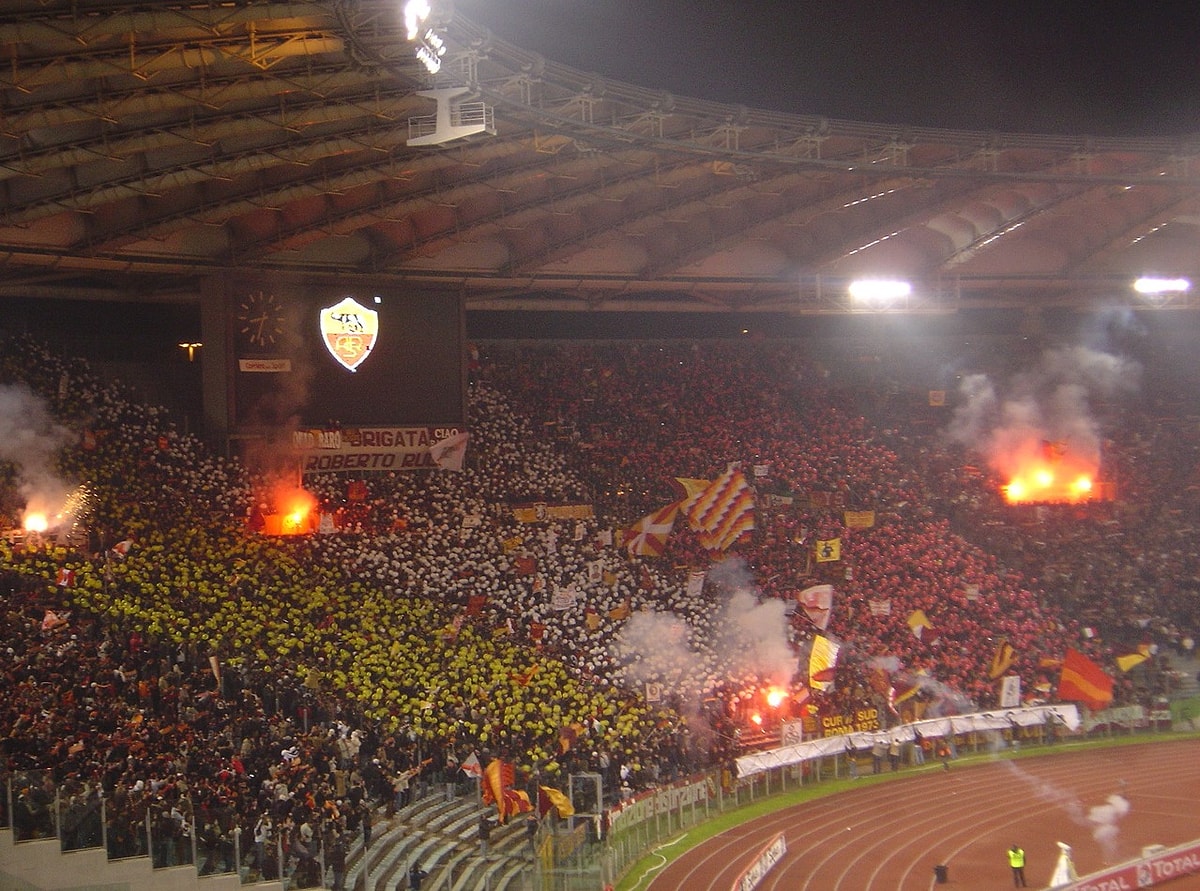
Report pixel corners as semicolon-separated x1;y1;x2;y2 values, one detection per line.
456;0;1200;137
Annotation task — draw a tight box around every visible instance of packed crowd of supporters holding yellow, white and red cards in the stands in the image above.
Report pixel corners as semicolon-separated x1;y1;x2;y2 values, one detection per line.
0;339;1200;875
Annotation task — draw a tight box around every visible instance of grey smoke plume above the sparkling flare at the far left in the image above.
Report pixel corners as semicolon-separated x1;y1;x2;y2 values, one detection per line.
0;383;74;514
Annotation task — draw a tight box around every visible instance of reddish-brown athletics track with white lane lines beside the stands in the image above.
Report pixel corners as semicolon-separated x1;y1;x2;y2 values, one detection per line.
638;738;1200;891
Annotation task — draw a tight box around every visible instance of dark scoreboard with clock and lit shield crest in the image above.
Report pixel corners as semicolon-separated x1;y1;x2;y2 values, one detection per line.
226;282;466;435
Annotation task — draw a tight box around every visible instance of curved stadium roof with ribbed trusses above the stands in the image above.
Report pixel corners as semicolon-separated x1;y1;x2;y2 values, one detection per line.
7;0;1200;313
